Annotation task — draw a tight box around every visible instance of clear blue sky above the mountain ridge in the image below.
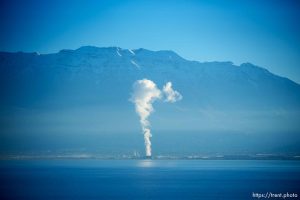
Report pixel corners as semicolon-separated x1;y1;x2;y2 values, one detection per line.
0;0;300;83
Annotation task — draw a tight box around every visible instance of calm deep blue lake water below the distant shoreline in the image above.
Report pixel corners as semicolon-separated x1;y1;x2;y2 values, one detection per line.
0;160;300;200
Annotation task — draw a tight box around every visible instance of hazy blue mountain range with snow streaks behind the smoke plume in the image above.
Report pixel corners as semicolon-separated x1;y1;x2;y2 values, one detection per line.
0;46;300;155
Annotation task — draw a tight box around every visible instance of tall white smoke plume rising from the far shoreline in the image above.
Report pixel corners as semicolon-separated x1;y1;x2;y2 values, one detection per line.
130;79;182;156
